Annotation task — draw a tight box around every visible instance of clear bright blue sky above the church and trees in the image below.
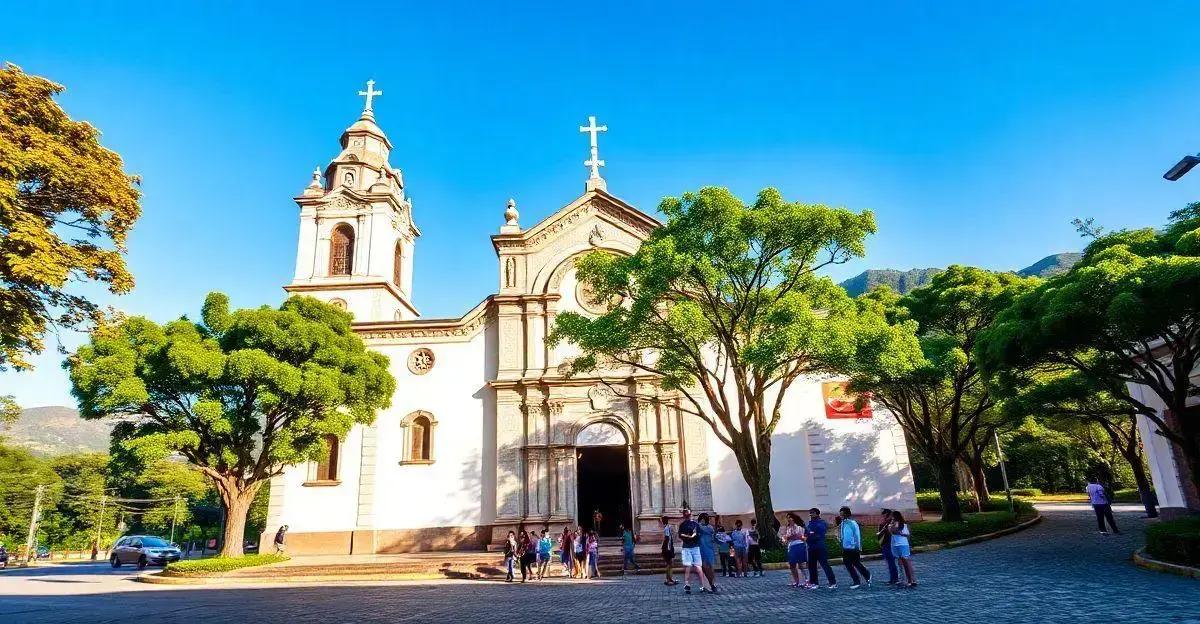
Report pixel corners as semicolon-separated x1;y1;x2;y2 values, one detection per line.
0;0;1200;407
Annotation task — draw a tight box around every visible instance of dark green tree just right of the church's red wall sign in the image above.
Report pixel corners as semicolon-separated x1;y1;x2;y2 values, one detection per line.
851;265;1037;522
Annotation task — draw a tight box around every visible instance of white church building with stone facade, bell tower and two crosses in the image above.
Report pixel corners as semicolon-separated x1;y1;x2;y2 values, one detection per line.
264;83;917;554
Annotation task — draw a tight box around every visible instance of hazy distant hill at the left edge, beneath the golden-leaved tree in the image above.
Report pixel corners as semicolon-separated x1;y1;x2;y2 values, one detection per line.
0;406;113;455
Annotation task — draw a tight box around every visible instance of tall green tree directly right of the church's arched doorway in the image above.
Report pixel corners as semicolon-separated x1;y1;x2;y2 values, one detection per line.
550;187;914;547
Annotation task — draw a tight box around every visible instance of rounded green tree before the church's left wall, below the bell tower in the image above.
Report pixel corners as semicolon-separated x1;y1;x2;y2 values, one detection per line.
65;293;396;556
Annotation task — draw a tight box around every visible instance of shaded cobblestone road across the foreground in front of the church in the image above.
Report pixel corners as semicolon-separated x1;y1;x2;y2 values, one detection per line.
0;505;1200;624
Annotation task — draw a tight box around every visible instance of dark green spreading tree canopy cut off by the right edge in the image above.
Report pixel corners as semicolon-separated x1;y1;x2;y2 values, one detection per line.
979;203;1200;496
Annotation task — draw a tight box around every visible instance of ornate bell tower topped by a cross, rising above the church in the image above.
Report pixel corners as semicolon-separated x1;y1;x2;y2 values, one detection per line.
283;80;421;322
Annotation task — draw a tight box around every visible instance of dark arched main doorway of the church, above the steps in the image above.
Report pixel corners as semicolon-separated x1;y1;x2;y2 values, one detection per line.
575;421;632;536
